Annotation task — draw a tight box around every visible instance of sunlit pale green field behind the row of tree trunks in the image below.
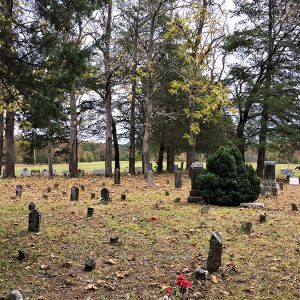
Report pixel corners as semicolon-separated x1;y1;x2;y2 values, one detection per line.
16;161;300;176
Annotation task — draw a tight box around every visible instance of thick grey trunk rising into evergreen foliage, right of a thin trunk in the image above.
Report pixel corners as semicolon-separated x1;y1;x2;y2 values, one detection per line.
69;90;78;177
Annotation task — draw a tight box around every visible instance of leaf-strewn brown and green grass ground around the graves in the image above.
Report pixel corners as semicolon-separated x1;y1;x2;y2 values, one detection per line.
0;174;300;300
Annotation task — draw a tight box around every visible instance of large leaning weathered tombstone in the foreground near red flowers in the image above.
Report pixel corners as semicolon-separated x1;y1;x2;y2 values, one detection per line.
206;232;223;273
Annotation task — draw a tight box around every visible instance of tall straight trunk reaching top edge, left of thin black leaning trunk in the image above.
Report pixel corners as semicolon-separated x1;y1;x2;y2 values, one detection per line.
104;0;112;177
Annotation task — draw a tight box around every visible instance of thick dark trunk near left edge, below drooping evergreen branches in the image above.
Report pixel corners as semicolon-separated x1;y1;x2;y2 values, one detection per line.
4;111;16;178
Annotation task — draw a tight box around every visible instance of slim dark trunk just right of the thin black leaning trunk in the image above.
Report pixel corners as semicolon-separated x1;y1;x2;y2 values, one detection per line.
129;73;136;175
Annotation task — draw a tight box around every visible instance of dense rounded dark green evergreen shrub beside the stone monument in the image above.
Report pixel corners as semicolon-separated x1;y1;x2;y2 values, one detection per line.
197;143;260;206
